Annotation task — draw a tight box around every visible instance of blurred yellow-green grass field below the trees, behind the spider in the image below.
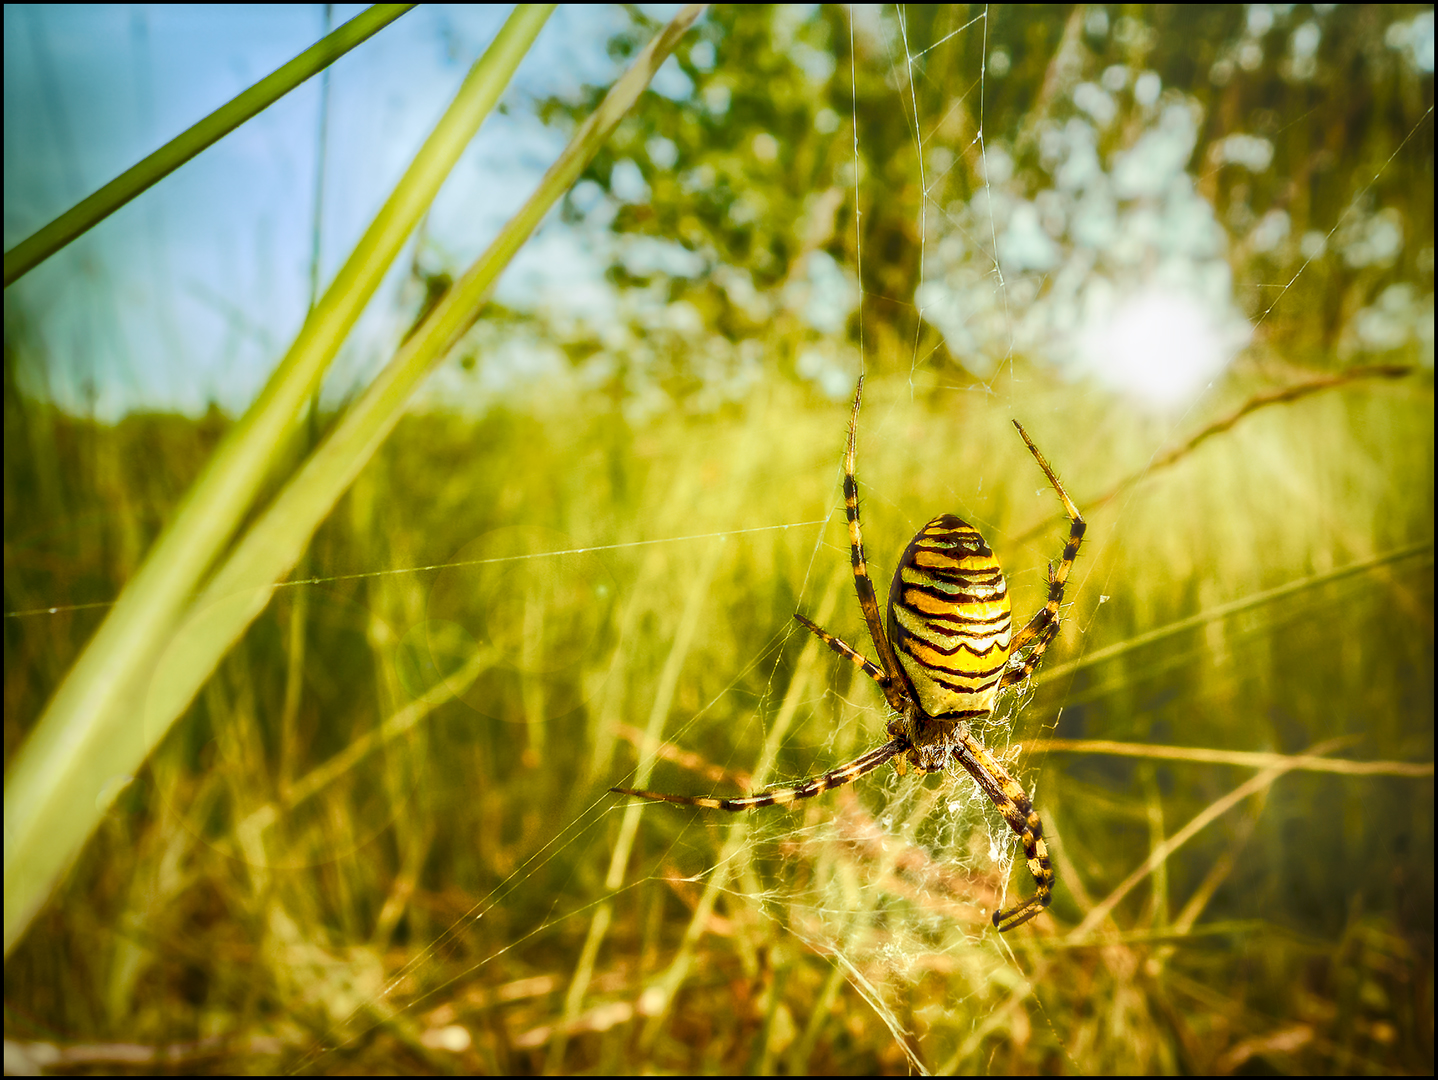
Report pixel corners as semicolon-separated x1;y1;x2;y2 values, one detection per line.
6;359;1432;1071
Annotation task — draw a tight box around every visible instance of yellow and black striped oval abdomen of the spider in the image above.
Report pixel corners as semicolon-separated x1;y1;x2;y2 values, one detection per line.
889;513;1014;719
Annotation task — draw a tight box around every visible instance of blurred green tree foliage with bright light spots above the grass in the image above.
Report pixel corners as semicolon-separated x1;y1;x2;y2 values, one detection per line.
526;4;1432;408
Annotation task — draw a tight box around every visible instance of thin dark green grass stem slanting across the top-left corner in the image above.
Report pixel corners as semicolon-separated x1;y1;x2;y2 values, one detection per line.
4;4;416;289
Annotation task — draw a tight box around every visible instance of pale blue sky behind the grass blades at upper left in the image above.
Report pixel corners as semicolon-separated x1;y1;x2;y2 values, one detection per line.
4;6;683;418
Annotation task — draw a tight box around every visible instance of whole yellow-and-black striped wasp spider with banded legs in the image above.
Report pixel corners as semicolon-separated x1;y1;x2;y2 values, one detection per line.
613;378;1084;930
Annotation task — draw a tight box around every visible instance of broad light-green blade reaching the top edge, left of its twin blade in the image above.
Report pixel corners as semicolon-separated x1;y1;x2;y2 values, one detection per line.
4;4;554;953
